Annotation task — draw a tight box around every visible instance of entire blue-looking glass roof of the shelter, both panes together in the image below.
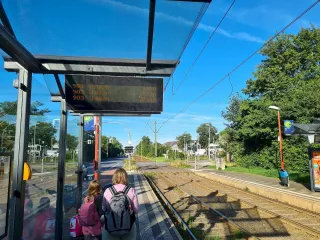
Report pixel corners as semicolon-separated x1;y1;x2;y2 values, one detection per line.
3;0;208;60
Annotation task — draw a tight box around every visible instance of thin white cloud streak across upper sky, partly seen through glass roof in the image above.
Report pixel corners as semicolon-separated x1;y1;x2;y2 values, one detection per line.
90;0;264;43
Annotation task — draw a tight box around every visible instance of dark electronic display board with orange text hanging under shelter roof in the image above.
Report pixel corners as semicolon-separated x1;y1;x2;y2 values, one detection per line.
65;75;163;113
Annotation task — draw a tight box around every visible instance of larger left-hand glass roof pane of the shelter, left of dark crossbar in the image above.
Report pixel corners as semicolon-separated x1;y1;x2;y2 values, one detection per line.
4;0;149;59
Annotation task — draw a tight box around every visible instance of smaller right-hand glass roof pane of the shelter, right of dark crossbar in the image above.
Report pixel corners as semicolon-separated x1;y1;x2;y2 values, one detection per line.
152;1;209;60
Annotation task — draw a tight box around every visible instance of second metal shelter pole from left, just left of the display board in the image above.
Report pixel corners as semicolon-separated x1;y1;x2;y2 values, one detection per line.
55;100;68;239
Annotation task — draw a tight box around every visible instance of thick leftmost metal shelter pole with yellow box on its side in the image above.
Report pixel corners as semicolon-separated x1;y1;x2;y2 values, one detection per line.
8;70;32;239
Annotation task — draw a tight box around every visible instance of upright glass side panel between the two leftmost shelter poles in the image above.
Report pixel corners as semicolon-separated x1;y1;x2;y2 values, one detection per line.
23;75;60;240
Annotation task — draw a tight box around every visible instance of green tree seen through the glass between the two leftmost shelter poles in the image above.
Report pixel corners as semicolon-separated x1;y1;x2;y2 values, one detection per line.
29;122;57;146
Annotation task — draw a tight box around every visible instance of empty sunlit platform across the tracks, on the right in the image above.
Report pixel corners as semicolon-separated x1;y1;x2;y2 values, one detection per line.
193;169;320;213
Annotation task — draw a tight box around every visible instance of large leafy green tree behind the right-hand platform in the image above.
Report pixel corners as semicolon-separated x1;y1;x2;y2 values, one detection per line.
222;26;320;171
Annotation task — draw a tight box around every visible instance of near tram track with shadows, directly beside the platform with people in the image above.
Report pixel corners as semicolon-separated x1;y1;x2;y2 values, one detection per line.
147;173;258;239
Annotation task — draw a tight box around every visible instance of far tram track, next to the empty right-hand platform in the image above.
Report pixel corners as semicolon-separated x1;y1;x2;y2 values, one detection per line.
149;173;320;239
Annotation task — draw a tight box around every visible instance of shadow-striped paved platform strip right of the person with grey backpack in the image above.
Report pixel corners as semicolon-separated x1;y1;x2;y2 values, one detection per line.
129;174;182;240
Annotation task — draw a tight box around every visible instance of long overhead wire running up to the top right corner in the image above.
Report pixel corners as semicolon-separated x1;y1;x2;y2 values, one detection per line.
158;0;320;130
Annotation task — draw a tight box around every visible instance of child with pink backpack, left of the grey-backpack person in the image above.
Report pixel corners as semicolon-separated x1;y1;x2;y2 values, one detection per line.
78;180;103;240
